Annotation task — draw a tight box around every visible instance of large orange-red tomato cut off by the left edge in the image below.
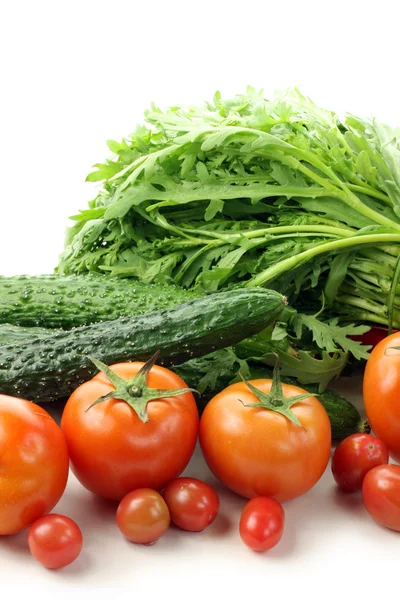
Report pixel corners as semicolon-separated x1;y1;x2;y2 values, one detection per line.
0;395;68;535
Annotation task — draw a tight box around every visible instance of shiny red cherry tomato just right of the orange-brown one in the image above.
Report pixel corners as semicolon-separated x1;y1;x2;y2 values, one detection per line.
163;477;219;531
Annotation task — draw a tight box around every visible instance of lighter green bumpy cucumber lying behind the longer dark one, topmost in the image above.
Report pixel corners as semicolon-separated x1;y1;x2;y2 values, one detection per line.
0;275;200;329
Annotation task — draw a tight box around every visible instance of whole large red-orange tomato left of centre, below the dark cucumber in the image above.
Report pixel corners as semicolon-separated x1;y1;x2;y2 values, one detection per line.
61;362;199;500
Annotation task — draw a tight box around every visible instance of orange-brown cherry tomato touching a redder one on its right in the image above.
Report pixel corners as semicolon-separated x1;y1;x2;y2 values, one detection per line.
117;488;171;544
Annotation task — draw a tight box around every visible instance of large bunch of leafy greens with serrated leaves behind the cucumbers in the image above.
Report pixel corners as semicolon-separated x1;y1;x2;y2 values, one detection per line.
58;88;400;386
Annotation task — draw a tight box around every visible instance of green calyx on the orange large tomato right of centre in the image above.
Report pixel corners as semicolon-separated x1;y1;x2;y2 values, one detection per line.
239;358;318;429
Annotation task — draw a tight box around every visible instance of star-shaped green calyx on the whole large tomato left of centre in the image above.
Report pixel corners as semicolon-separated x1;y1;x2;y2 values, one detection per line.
85;350;197;423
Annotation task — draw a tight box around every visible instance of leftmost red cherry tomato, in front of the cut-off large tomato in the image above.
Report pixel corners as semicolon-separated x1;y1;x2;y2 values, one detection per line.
28;514;83;569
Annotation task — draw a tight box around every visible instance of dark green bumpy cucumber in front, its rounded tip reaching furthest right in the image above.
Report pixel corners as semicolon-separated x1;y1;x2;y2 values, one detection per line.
0;289;286;402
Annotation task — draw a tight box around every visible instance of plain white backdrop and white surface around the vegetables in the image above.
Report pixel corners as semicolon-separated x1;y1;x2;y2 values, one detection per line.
0;0;400;598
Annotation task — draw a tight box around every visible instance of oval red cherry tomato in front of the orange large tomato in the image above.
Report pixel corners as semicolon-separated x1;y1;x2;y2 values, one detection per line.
239;496;285;552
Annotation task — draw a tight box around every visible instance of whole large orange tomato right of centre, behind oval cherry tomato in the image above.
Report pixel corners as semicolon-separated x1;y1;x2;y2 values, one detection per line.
200;379;331;501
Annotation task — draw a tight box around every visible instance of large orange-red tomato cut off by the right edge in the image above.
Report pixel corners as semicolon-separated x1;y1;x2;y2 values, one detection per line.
363;332;400;462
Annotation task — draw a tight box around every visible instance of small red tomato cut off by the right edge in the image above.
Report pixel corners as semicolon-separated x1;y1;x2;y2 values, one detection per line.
362;465;400;531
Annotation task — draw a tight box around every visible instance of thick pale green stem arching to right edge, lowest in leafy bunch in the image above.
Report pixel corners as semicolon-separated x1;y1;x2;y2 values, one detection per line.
247;233;400;287
